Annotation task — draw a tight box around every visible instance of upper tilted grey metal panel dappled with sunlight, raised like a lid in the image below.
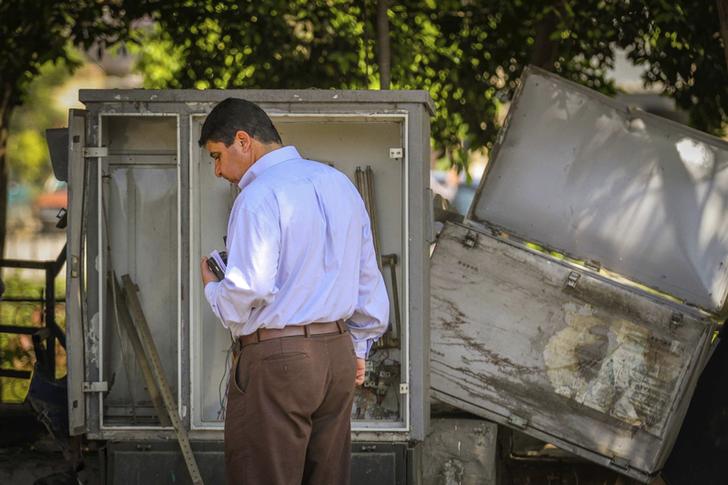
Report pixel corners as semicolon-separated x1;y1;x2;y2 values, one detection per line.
469;69;728;312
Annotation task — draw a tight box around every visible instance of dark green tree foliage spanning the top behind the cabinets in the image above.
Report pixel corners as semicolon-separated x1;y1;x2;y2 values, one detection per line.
0;0;728;250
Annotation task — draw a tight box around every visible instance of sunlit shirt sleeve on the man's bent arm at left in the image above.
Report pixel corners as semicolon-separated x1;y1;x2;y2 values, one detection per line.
205;199;281;328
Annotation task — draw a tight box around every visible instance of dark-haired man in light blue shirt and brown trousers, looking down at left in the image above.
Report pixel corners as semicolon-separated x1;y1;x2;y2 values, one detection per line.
199;98;389;485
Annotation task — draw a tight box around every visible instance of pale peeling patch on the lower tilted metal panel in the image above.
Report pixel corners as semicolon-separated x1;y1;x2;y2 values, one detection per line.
543;303;684;434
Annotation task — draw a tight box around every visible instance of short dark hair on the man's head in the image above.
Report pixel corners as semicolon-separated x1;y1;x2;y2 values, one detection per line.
198;98;282;146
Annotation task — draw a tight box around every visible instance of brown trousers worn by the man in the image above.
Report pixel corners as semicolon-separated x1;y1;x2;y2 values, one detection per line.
225;333;356;485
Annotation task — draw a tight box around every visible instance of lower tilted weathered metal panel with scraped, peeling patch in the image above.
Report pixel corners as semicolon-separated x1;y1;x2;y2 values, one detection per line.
431;223;712;479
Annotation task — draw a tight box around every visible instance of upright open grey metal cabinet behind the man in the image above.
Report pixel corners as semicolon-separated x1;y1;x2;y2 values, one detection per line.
67;90;433;452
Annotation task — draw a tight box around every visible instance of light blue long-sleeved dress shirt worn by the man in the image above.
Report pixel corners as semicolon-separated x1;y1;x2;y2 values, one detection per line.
205;146;389;358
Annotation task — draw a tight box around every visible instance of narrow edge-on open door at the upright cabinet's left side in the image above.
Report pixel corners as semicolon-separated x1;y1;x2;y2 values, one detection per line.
66;109;86;435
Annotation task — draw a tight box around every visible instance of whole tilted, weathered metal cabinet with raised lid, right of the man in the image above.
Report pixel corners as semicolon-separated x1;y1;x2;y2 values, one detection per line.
431;69;728;481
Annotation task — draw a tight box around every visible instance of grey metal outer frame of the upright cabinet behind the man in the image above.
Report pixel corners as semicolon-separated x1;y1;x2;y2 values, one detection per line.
72;90;434;442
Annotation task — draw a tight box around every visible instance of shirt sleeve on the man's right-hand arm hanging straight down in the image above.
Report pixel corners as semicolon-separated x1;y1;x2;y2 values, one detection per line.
347;209;389;359
